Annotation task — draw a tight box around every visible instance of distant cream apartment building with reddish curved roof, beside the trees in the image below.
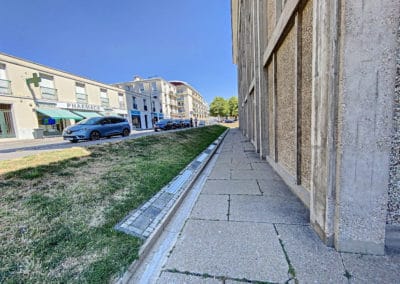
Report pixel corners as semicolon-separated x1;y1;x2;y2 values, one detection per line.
170;81;209;119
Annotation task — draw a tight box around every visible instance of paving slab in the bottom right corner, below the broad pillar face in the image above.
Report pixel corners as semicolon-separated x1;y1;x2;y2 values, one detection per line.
342;253;400;284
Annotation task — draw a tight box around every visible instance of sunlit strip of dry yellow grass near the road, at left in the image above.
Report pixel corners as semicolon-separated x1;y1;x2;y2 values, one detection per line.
0;147;90;175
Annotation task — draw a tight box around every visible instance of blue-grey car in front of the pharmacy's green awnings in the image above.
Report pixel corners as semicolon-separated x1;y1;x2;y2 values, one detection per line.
62;116;131;143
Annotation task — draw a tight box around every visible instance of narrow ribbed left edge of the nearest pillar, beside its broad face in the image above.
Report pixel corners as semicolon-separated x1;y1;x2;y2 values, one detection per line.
310;0;340;246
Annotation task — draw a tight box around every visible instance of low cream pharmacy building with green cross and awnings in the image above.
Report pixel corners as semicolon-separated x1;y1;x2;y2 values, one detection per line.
0;53;127;139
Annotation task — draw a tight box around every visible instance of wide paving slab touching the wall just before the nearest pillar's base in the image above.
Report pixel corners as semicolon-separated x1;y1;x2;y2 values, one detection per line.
229;195;309;224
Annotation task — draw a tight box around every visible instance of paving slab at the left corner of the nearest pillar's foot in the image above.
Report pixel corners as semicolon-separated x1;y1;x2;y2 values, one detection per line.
276;224;348;283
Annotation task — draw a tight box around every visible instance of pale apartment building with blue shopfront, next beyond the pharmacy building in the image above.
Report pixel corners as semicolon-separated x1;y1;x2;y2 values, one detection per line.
113;76;178;129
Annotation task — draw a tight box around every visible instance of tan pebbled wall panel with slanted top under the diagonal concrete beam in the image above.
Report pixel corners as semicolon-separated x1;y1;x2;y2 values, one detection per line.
276;28;297;176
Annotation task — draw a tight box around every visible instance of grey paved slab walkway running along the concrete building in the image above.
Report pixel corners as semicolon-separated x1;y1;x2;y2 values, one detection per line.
134;129;400;283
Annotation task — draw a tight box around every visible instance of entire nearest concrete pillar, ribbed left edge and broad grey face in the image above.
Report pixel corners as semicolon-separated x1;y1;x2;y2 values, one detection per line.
310;0;400;254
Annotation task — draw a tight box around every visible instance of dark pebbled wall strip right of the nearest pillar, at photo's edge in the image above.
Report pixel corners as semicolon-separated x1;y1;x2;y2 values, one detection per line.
387;23;400;226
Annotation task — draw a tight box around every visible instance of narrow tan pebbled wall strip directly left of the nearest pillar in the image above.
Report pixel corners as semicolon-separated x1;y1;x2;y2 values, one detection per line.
300;0;313;190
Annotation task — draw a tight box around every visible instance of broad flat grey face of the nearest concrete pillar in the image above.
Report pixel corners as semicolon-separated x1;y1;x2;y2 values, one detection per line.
335;0;400;254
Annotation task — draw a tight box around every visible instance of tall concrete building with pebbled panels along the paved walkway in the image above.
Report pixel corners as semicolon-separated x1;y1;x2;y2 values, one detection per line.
231;0;400;254
